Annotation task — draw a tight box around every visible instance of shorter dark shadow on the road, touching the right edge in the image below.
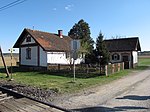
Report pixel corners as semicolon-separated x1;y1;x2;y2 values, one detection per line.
116;95;150;100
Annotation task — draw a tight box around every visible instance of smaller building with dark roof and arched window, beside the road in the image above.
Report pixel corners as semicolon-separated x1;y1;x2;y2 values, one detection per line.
105;37;141;69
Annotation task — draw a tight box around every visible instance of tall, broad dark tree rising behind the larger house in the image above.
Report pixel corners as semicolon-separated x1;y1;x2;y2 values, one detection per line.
68;19;94;55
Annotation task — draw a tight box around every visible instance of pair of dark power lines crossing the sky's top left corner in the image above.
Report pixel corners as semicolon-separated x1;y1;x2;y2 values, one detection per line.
0;0;27;11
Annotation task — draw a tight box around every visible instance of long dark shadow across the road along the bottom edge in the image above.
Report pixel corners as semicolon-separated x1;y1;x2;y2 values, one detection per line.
73;106;148;112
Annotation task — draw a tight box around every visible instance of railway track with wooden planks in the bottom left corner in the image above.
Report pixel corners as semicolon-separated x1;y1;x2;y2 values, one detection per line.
0;86;72;112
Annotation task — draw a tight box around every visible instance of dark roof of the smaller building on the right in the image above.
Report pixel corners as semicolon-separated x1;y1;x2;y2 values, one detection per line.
104;37;141;52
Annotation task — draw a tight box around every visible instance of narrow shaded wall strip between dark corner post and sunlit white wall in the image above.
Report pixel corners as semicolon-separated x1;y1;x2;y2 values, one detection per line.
40;47;47;67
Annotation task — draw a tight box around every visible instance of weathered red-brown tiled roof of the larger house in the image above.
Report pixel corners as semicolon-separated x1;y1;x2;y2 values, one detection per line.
14;29;72;51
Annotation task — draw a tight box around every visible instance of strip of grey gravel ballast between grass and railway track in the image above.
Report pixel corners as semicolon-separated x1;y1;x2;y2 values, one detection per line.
0;80;57;102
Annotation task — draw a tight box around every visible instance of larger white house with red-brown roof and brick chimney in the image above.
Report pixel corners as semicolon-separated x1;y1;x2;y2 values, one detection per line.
14;29;84;67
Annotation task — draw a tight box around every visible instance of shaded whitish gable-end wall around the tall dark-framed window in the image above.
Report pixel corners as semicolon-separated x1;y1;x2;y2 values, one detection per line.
21;46;38;66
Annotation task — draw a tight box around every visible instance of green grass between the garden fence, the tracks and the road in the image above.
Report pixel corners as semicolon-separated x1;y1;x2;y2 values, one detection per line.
0;59;150;94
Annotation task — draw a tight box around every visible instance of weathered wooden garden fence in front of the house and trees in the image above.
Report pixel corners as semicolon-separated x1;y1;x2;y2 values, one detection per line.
47;62;124;76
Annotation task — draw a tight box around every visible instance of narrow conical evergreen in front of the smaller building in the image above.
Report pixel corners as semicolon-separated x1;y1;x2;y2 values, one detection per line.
96;32;110;65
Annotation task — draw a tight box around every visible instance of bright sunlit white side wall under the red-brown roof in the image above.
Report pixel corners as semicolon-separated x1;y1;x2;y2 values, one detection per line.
47;52;70;64
